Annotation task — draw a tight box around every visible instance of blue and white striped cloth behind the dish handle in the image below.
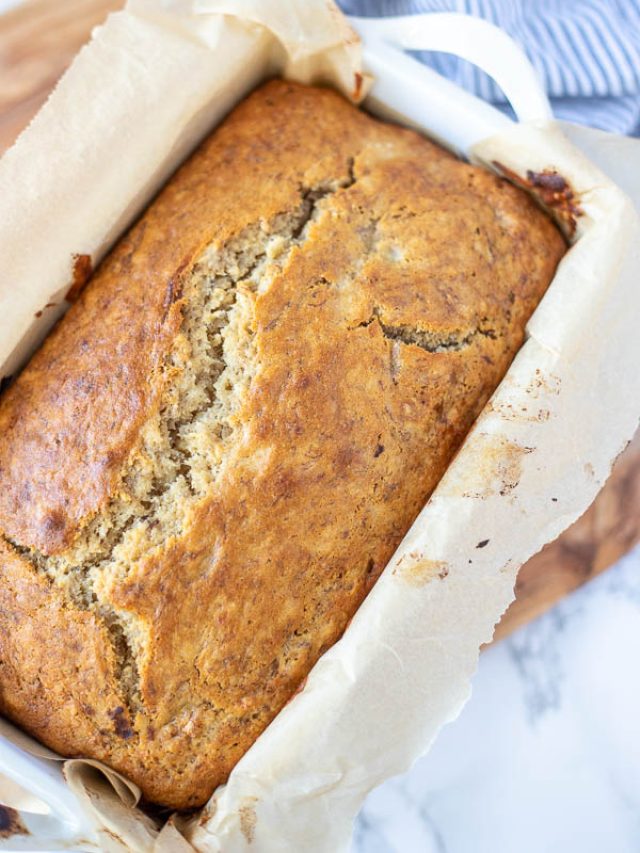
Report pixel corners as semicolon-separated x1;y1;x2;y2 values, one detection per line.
338;0;640;136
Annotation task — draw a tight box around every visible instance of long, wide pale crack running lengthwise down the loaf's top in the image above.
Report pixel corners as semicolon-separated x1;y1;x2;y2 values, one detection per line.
3;171;355;712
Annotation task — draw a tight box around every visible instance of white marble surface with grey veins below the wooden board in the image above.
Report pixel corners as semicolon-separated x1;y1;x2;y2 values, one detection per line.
352;548;640;853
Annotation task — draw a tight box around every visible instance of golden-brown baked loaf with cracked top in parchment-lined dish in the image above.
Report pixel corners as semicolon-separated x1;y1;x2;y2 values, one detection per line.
0;81;565;808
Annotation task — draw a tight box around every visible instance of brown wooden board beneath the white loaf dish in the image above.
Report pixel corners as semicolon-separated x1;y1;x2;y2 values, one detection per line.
0;0;640;637
